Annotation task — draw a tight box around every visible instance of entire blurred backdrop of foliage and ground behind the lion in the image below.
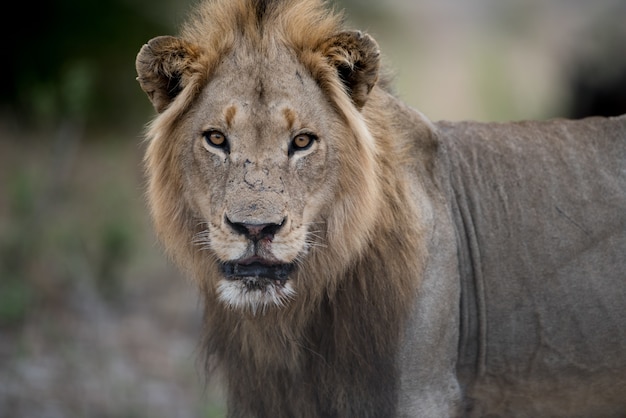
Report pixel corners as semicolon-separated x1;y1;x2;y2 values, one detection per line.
0;0;626;418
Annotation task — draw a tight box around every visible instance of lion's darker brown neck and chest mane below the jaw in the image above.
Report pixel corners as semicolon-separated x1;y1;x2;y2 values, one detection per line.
202;219;419;417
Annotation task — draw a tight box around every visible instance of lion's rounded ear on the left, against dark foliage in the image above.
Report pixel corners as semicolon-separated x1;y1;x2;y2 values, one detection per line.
135;36;198;113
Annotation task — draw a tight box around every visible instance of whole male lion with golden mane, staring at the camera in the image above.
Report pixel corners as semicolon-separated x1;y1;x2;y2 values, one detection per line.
136;0;626;418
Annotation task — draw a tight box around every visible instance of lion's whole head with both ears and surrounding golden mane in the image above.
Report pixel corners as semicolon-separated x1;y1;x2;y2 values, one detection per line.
137;0;382;312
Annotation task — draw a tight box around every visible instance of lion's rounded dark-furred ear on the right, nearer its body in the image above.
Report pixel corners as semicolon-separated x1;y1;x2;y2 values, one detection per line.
324;31;380;109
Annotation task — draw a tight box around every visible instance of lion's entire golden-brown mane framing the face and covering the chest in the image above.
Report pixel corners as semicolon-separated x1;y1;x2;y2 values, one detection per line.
140;0;434;417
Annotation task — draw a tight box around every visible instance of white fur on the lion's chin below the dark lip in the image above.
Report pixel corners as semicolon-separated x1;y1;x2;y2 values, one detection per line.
217;279;296;315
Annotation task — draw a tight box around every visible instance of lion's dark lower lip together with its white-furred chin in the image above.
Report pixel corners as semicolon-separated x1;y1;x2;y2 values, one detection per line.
217;263;296;315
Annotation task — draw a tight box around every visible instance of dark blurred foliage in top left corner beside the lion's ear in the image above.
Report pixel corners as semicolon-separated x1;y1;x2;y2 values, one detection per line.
0;0;193;132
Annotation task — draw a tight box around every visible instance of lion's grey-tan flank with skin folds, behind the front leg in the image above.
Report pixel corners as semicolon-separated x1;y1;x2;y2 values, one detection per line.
438;117;626;417
